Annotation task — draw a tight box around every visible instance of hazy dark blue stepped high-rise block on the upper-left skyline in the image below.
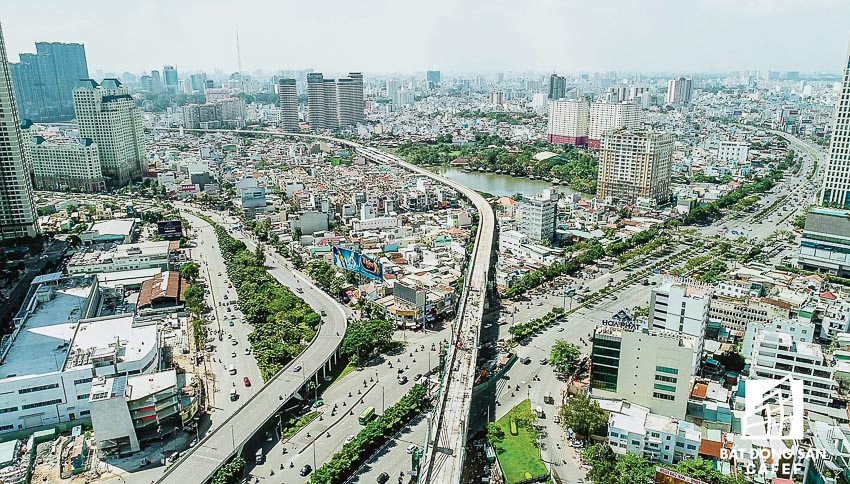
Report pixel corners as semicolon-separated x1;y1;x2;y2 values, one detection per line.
9;42;89;121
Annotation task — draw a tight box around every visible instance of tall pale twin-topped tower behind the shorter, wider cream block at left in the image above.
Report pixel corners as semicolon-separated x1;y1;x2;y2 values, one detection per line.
74;78;144;186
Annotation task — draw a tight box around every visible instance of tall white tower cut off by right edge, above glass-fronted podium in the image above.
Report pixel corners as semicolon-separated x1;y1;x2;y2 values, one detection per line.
821;40;850;208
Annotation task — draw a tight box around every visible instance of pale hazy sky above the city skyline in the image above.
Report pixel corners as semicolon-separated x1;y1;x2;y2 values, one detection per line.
0;0;850;77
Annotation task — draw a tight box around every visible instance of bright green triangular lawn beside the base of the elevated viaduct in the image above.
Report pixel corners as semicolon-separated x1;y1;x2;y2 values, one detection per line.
493;400;548;484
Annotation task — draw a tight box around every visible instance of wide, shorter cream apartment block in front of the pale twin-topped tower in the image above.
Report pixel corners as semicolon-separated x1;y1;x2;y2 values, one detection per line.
29;136;106;192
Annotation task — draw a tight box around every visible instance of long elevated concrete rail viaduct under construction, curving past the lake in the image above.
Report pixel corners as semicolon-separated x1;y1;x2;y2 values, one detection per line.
157;128;496;483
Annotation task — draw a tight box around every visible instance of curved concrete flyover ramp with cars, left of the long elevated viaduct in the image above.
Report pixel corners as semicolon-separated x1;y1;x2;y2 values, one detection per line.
159;206;347;484
